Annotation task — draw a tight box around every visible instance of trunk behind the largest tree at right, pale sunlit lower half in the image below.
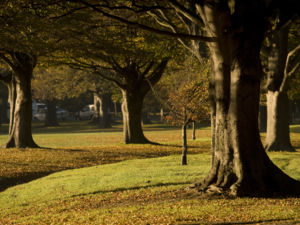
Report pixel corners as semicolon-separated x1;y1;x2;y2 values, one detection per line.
265;27;295;151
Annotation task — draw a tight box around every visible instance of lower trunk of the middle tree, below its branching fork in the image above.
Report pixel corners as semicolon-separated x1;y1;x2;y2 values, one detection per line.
122;89;149;144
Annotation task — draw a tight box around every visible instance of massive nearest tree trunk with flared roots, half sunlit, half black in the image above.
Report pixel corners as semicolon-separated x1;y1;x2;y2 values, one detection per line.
199;1;300;196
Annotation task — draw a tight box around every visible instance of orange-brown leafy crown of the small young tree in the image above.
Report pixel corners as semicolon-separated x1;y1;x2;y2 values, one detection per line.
164;58;210;125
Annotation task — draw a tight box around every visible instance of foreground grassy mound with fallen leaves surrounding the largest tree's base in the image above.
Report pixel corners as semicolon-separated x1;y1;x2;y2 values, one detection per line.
0;152;300;224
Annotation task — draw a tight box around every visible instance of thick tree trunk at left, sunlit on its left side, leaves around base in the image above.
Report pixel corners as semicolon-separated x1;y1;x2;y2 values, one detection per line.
6;53;38;148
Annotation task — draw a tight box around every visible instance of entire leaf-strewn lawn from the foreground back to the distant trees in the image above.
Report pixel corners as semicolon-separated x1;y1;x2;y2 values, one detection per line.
0;122;300;224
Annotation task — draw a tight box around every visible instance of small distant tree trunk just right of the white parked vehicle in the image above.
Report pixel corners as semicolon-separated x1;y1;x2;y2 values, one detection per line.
92;93;111;128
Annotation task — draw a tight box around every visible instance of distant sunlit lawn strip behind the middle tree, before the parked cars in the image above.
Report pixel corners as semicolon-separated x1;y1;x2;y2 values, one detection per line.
0;121;210;148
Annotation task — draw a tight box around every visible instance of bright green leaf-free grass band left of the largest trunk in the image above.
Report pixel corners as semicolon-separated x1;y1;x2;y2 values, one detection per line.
0;154;210;208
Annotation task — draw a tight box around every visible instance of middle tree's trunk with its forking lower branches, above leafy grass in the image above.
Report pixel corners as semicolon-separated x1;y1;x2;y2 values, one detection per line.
109;58;169;144
